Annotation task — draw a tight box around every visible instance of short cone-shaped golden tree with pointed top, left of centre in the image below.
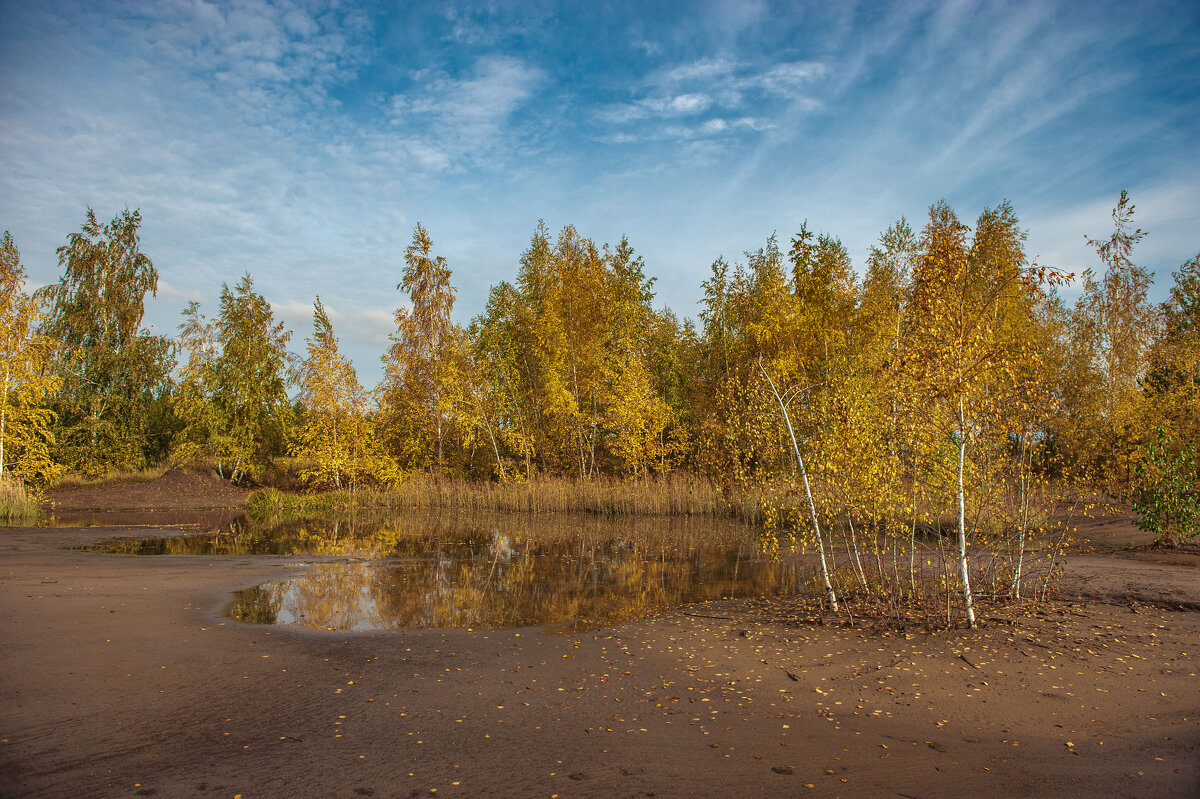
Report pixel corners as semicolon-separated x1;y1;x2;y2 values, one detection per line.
292;298;390;491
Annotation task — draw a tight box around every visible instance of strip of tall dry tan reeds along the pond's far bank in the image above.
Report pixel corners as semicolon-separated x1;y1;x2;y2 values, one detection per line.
251;473;760;524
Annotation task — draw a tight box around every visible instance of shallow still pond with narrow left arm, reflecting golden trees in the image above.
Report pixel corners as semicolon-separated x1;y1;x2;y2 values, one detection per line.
72;515;811;630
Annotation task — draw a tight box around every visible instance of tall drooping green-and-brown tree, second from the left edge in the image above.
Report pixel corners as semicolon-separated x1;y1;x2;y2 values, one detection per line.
41;208;172;473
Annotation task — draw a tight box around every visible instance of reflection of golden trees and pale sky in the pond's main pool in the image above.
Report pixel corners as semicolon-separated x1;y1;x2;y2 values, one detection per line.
230;533;800;630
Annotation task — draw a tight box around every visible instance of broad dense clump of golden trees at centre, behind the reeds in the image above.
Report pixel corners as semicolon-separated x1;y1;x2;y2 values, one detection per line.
472;223;686;479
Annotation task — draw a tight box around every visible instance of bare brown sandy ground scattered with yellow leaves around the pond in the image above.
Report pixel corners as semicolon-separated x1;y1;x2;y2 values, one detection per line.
0;506;1200;799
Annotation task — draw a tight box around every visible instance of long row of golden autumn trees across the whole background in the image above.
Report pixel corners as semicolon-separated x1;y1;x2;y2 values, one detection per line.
0;192;1200;519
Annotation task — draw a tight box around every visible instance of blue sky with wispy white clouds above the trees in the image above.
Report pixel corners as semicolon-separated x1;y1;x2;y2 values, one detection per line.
0;0;1200;385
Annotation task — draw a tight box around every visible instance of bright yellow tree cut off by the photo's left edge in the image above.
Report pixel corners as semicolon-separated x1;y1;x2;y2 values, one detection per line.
0;230;61;483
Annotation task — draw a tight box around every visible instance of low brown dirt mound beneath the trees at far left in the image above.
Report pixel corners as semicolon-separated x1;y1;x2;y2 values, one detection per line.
46;469;251;511
